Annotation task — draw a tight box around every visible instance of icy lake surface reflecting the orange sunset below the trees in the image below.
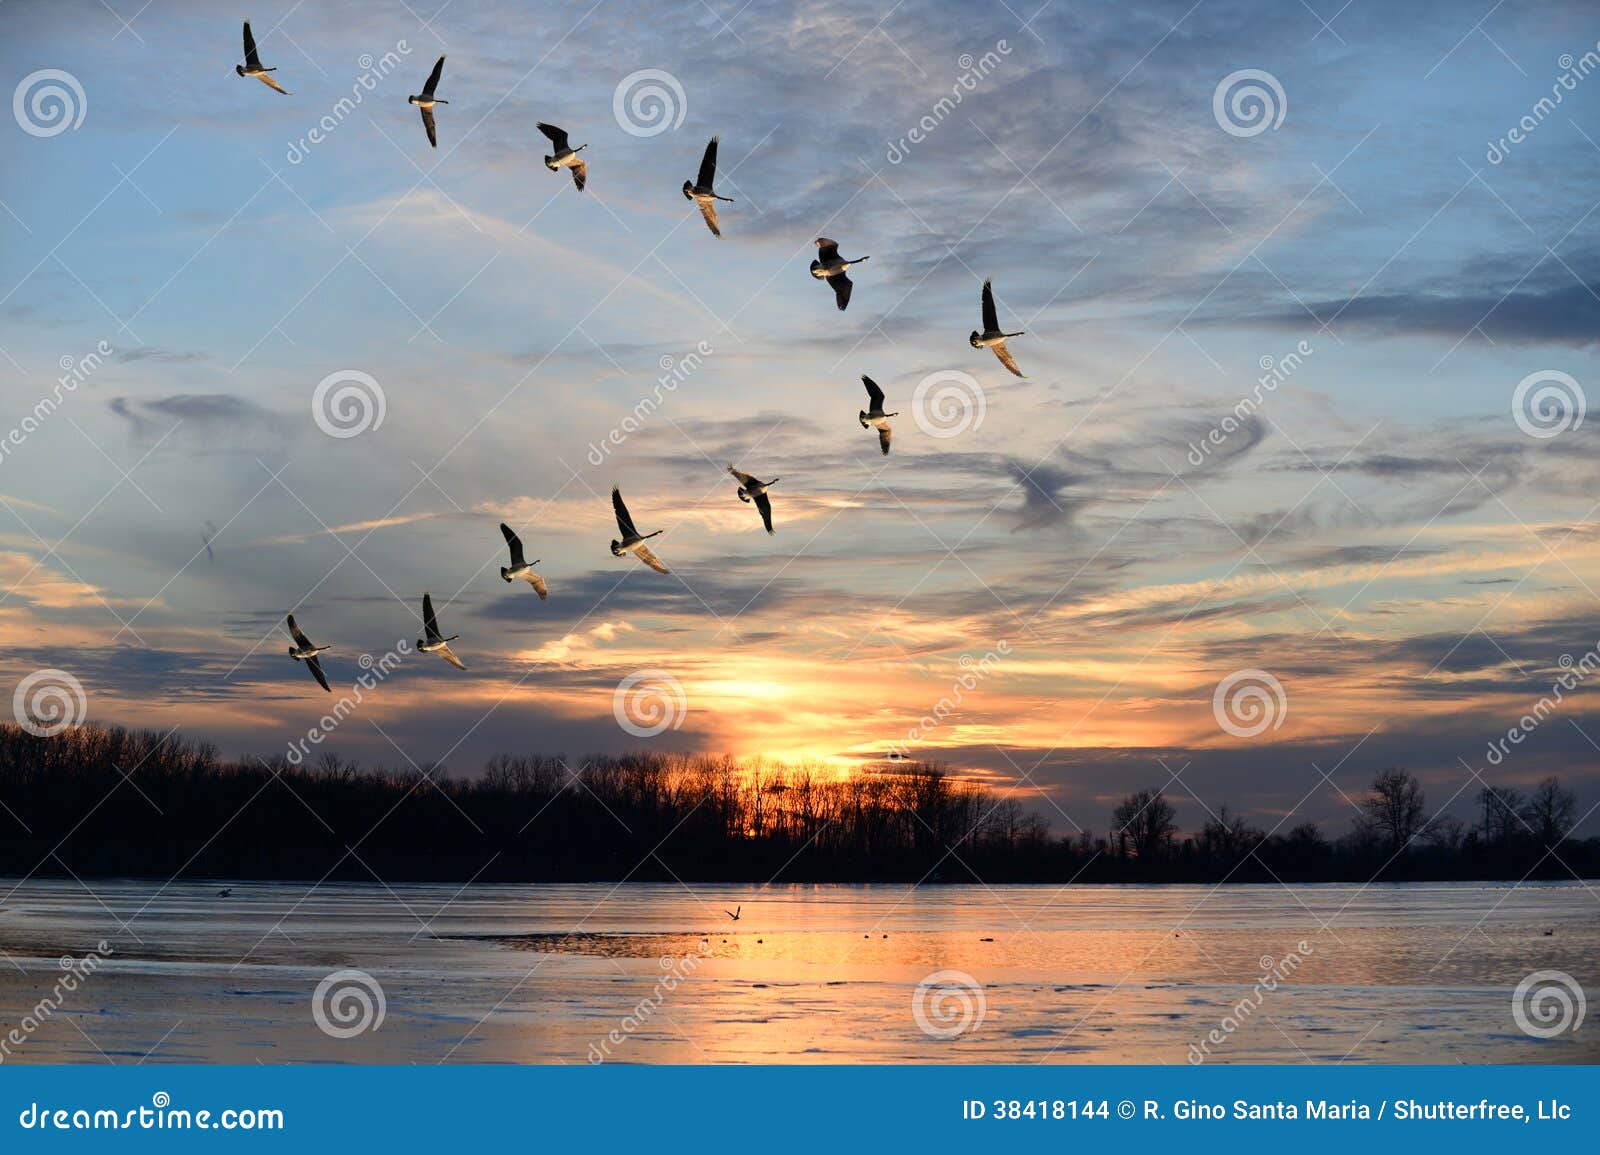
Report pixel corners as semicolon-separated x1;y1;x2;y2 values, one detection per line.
0;880;1600;1064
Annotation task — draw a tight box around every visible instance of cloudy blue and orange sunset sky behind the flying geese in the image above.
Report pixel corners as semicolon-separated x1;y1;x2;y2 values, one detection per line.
0;0;1600;833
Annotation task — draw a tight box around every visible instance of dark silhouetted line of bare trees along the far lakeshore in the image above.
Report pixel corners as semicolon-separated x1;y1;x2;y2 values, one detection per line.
0;725;1600;883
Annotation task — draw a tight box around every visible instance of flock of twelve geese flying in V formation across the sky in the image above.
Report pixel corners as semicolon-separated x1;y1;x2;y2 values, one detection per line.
234;21;1022;693
